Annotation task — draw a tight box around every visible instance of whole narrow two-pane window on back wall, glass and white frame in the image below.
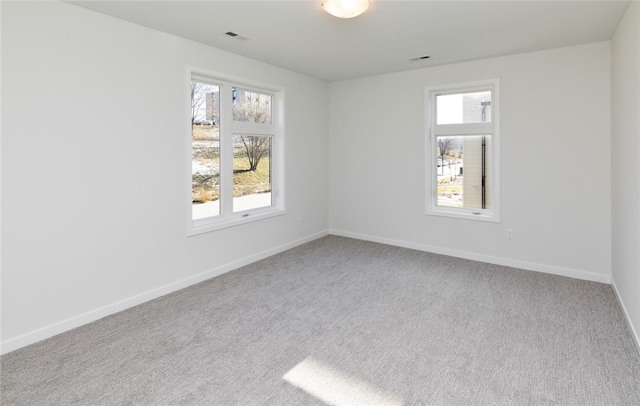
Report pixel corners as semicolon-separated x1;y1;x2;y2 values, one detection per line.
426;79;500;222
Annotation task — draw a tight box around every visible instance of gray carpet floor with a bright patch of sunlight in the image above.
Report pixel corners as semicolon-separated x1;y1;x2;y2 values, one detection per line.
1;236;640;406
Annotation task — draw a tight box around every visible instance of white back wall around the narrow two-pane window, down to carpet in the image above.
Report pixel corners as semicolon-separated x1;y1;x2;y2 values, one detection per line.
329;41;611;282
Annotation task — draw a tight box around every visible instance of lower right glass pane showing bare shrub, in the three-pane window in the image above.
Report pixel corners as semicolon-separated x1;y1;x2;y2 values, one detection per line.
233;134;271;213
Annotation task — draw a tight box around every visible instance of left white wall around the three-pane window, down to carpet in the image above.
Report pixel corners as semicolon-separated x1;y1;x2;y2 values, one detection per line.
1;2;329;352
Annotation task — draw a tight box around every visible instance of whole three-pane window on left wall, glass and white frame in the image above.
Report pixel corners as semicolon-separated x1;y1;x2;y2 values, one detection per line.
186;68;284;235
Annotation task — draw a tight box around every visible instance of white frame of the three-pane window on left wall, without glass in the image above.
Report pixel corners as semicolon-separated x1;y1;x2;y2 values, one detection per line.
184;66;286;236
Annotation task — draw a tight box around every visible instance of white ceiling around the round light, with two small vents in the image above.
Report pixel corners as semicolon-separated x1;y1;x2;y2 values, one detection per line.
69;0;630;81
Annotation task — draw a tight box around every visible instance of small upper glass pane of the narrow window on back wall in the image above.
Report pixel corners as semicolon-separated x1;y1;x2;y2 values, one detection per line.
436;91;491;125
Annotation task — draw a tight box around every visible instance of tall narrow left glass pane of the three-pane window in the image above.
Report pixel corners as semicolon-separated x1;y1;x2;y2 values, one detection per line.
191;80;220;220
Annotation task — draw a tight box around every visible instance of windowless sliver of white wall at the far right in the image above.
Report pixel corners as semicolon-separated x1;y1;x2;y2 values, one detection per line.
611;2;640;344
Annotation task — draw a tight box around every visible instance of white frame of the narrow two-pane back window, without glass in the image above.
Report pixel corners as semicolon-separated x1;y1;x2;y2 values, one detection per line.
425;78;500;223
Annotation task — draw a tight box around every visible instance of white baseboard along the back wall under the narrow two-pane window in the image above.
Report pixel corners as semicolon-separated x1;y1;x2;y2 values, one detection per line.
329;229;611;283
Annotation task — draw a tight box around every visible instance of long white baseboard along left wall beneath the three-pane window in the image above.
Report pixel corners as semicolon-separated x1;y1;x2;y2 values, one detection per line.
0;231;329;354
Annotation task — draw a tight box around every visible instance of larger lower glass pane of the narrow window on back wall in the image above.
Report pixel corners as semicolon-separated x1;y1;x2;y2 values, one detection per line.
436;135;492;209
